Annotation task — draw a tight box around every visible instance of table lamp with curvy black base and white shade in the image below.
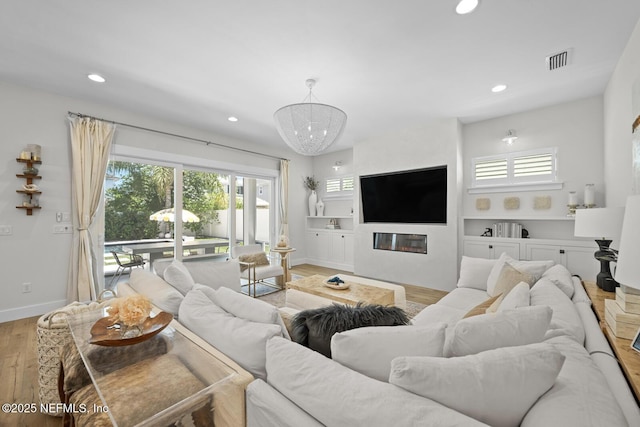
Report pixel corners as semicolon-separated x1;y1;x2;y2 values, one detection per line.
573;207;624;292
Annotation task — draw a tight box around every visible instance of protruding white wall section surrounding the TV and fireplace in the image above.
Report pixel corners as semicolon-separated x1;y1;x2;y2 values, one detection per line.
353;119;461;290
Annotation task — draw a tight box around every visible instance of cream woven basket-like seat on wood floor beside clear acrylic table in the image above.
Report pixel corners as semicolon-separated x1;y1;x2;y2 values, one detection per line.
37;302;107;417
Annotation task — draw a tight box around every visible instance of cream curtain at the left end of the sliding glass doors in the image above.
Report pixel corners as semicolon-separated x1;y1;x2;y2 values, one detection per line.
67;117;115;302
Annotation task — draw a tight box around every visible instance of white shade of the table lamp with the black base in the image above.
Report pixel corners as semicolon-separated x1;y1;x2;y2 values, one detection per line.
573;207;624;240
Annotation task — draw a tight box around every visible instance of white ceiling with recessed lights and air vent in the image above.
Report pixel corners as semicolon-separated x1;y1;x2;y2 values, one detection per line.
0;0;640;155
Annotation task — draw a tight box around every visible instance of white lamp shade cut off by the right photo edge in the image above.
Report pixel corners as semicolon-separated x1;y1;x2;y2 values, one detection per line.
615;195;640;289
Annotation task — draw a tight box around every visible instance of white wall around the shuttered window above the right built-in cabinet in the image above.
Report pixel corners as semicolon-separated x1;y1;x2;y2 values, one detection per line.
462;97;605;217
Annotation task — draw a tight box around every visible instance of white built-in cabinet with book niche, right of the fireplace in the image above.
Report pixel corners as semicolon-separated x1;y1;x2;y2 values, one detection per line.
462;217;600;281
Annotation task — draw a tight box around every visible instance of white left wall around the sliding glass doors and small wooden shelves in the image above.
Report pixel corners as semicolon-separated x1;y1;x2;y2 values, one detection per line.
0;82;312;322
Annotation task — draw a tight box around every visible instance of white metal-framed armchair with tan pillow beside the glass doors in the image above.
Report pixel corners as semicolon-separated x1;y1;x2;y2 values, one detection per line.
231;244;284;298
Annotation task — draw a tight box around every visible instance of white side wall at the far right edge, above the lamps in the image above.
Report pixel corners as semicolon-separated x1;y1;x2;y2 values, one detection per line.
604;21;640;206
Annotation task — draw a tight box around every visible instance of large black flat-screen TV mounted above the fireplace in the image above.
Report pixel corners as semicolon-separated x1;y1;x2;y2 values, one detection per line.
360;166;447;224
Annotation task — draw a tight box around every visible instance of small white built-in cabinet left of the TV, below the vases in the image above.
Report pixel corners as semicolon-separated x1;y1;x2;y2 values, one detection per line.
306;216;354;271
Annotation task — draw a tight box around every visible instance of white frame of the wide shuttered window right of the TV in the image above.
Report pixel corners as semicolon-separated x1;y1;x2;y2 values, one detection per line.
468;147;562;193
